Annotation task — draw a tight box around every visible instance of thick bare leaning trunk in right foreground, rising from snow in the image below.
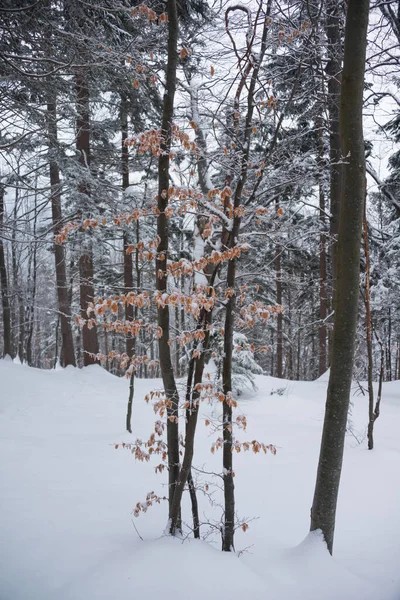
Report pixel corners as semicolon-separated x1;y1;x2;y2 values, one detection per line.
311;0;369;553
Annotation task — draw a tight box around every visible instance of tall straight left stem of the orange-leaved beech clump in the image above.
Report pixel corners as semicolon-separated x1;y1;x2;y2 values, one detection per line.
156;0;180;528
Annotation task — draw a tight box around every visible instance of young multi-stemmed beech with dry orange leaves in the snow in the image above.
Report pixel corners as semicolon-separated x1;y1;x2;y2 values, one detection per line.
57;0;280;551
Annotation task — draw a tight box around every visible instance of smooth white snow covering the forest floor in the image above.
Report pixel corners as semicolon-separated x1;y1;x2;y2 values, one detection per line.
0;361;400;600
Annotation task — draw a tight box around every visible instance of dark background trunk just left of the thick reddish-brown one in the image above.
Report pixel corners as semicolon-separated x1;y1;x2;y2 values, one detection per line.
47;94;76;367
